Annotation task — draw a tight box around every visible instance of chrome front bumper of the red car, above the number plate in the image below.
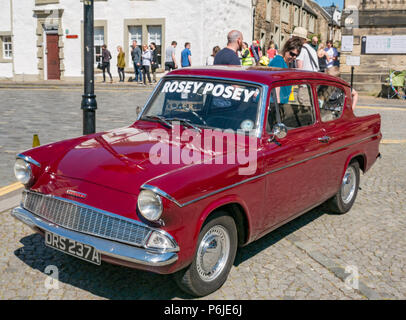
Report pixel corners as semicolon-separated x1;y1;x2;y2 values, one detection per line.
11;207;178;267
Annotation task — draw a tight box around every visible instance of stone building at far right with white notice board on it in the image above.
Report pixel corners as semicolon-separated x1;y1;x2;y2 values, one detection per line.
341;0;406;94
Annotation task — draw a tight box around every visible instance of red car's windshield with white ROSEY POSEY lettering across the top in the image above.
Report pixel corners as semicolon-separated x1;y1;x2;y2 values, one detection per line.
141;78;262;133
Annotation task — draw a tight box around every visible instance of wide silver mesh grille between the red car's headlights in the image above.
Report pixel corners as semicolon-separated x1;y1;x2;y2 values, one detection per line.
22;190;152;246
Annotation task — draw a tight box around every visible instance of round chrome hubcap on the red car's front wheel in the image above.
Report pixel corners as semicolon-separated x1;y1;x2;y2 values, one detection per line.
196;225;230;281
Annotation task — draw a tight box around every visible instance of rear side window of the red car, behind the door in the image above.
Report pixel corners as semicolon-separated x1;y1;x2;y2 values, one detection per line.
317;86;345;122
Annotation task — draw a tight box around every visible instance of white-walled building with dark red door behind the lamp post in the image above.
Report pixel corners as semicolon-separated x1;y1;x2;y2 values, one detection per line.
0;0;252;81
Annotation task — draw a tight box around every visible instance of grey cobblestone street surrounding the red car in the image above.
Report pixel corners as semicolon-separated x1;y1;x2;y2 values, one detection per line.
0;88;406;299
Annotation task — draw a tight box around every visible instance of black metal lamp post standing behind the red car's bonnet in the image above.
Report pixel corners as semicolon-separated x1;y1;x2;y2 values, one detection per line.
81;0;97;135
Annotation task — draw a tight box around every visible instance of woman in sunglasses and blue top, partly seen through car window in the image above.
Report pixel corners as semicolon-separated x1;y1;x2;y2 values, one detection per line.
268;37;303;104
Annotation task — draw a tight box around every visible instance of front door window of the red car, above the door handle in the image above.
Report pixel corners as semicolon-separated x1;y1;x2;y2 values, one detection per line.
267;84;315;132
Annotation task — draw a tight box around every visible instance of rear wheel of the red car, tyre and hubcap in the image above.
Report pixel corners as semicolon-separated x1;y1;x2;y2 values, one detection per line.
328;161;360;214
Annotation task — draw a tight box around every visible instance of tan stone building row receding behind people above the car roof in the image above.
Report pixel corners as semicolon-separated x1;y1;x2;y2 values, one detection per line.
254;0;341;49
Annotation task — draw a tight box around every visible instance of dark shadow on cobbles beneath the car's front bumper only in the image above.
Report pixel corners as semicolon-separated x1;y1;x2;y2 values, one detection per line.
14;234;191;300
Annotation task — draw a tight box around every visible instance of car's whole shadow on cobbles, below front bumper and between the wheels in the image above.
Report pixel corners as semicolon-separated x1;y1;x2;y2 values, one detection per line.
14;207;332;300
